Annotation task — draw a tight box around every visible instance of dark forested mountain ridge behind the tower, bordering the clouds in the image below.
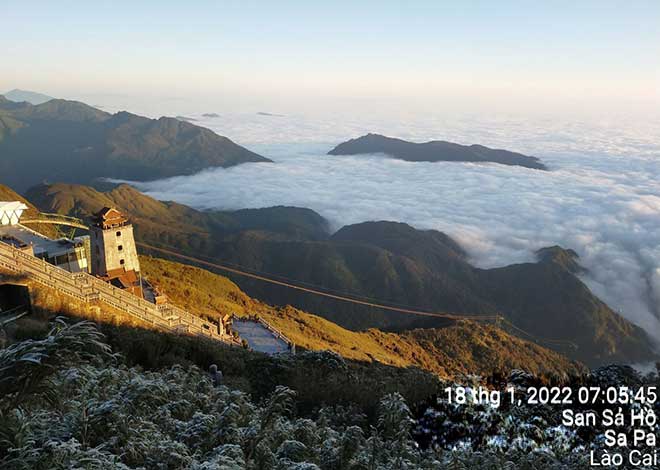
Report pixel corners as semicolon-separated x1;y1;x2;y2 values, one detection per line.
27;185;657;365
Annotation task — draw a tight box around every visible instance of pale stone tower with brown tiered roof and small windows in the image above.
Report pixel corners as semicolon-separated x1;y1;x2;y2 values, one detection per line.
90;207;140;279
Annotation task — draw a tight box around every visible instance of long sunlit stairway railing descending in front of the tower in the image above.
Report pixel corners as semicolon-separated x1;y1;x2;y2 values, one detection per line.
0;242;236;343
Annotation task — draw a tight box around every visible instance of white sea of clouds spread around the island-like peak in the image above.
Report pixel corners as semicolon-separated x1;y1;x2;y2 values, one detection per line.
116;114;660;339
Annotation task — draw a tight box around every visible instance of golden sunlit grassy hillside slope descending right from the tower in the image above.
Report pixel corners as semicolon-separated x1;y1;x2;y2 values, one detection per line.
141;253;584;377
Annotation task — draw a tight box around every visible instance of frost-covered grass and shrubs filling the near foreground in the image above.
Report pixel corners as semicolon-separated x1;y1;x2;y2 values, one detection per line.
0;319;658;470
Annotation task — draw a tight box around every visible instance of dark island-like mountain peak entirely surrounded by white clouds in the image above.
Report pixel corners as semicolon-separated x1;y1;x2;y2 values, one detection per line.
328;134;547;170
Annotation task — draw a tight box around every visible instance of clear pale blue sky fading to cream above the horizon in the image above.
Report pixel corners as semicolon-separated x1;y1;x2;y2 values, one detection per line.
0;0;660;114
